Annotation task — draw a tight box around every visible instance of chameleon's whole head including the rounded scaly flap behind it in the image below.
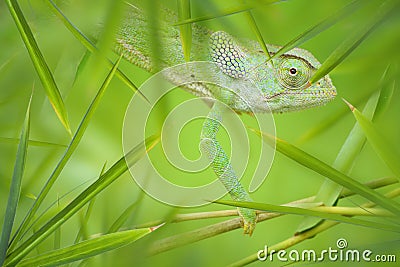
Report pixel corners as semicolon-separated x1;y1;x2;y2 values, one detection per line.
210;31;336;113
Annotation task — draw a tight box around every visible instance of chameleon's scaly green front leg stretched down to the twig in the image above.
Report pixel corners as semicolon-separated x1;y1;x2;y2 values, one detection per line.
200;101;257;235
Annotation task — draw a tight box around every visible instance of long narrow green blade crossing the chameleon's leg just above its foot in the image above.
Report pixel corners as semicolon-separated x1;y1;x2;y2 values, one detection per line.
215;200;400;232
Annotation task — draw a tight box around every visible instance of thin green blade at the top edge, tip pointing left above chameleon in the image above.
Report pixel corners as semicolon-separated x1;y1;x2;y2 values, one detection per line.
173;0;281;26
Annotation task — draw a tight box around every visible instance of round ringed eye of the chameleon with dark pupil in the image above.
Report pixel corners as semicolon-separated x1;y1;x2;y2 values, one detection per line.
277;57;311;90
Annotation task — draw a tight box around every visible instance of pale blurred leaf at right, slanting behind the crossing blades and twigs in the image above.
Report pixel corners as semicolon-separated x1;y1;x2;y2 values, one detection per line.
297;90;379;232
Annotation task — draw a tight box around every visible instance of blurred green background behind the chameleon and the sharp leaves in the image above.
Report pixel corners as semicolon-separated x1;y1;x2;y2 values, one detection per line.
0;0;400;267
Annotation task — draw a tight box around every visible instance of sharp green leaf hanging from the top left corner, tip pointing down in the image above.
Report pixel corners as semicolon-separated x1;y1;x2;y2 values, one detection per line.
6;0;71;135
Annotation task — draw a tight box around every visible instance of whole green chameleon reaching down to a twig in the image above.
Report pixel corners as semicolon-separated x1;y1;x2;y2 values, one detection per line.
116;3;336;235
